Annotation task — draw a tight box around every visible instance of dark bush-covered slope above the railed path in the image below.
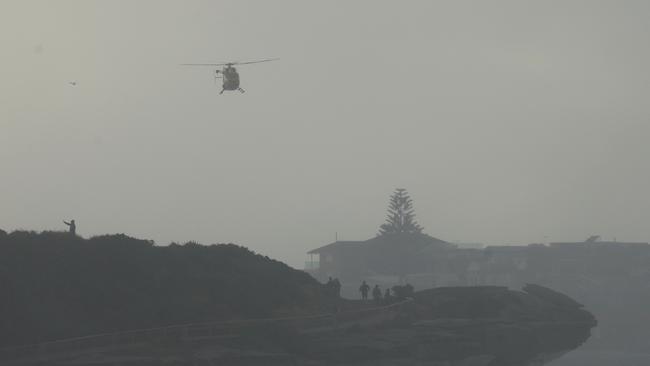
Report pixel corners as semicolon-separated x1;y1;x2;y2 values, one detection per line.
0;231;334;346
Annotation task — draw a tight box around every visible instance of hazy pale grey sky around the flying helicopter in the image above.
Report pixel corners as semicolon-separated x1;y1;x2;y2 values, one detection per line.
0;0;650;266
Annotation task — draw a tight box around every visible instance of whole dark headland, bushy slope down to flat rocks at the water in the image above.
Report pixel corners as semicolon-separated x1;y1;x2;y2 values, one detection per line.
0;231;596;366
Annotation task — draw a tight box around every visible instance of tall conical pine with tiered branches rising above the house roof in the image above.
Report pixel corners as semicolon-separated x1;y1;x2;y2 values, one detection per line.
379;188;422;235
